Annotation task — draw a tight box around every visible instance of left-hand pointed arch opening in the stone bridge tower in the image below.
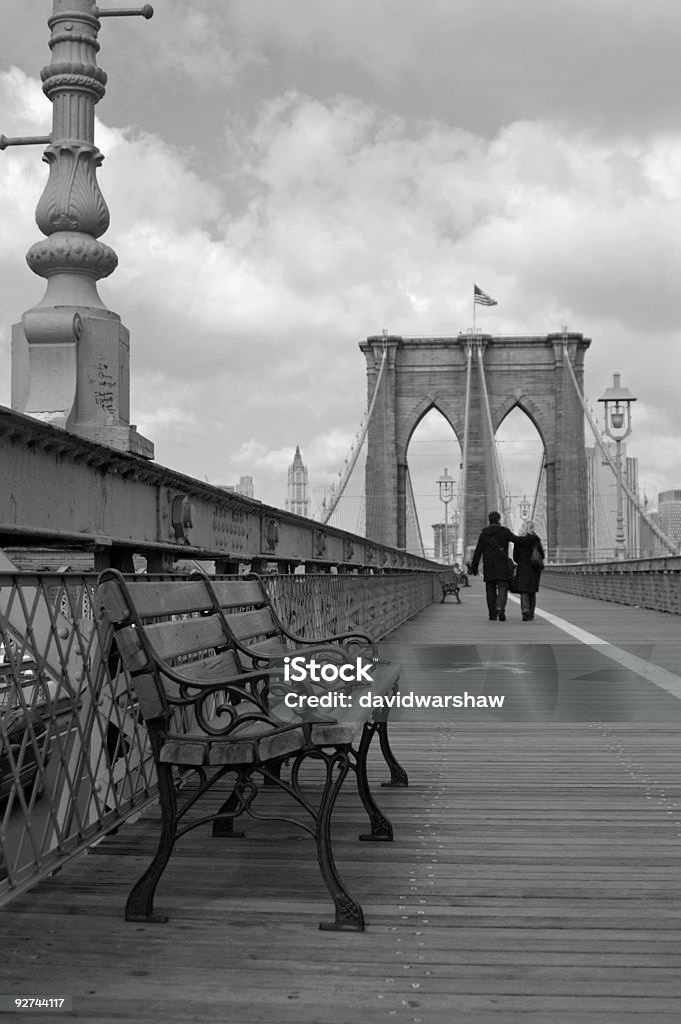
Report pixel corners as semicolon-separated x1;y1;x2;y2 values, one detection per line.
407;406;462;561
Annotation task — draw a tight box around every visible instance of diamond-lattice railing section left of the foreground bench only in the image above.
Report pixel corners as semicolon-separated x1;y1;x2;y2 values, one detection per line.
0;573;155;900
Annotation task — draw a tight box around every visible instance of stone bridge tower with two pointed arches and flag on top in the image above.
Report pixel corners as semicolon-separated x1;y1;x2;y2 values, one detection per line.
359;333;591;560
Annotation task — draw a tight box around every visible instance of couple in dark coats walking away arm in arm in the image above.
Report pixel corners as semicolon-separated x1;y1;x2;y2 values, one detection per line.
470;512;545;623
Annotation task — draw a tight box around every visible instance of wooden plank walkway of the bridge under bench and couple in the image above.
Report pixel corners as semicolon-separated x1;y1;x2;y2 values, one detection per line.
0;581;681;1024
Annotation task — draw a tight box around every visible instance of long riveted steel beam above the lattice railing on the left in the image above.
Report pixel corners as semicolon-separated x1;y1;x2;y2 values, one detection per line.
0;407;441;571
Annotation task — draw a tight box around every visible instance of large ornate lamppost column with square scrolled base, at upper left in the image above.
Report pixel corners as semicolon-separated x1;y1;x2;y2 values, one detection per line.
5;0;154;459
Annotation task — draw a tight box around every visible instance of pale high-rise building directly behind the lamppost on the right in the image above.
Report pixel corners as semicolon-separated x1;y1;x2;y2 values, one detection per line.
587;442;640;561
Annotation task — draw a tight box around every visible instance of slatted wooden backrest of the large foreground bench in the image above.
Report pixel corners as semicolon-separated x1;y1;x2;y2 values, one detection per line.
98;569;286;719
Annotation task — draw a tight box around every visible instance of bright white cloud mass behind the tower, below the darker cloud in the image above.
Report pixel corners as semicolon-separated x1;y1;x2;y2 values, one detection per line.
0;57;681;520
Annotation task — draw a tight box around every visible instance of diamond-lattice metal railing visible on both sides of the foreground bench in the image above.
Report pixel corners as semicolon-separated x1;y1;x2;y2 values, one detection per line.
0;572;441;904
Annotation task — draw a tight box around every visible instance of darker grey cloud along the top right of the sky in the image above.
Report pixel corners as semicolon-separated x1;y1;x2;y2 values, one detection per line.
205;0;681;137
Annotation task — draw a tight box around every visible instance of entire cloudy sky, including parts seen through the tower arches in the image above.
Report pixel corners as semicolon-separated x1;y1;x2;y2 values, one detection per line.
0;0;681;544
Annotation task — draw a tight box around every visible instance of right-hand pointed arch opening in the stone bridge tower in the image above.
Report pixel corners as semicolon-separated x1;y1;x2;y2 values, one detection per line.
495;404;546;536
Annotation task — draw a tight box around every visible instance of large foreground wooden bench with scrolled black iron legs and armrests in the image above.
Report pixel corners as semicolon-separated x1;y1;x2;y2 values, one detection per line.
98;569;408;931
